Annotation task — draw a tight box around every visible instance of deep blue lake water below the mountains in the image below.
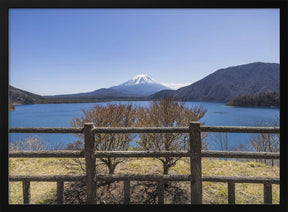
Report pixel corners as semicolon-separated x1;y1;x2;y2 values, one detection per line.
9;101;280;149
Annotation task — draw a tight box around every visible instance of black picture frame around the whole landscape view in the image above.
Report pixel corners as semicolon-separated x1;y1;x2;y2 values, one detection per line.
0;0;288;211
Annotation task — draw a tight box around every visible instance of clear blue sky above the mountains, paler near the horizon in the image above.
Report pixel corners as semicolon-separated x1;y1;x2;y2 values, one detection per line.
9;9;280;95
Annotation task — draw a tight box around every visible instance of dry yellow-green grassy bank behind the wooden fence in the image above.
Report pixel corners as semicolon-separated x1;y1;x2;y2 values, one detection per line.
9;158;280;204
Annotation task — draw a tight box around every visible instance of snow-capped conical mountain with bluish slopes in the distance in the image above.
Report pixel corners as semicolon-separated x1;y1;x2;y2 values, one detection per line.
110;74;171;96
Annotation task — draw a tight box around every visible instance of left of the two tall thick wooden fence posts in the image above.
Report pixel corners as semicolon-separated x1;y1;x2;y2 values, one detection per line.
84;123;96;204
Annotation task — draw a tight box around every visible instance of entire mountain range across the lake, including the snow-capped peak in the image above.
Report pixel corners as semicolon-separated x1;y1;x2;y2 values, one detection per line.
9;62;280;107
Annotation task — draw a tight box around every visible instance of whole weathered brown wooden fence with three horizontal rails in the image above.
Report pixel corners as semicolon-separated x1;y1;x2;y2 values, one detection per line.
9;122;280;204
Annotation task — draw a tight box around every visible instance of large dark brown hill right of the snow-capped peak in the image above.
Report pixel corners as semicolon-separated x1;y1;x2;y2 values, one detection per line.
150;62;280;102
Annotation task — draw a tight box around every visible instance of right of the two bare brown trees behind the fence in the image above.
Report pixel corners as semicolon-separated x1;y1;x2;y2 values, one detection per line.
137;98;207;174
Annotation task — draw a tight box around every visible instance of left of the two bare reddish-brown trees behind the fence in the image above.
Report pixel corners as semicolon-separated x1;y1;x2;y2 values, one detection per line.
70;104;136;174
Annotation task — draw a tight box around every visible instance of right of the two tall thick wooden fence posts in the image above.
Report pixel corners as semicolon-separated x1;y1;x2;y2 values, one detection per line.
189;122;202;204
